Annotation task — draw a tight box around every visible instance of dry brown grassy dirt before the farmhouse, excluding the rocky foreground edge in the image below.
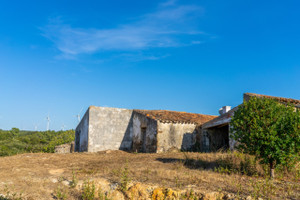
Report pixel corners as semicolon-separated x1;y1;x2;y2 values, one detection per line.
0;151;300;199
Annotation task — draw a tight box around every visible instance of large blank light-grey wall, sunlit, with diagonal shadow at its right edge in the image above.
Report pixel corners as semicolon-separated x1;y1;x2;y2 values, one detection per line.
88;106;133;152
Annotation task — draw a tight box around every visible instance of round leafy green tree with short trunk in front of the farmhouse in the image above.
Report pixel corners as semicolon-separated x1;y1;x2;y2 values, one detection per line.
231;97;300;178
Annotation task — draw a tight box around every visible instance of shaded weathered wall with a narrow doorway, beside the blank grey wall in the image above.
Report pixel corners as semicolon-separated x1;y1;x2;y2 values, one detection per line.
132;112;157;153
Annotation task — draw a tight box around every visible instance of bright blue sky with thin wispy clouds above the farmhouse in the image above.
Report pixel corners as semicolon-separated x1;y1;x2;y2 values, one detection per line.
0;0;300;130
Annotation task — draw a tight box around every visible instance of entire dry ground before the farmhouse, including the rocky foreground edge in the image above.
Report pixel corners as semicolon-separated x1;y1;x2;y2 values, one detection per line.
0;151;300;200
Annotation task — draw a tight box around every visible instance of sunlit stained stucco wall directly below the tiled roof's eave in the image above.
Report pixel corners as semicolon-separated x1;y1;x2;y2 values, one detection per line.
157;122;197;152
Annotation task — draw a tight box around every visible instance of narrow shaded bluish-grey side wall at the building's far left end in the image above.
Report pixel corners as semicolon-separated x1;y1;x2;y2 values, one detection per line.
75;109;90;152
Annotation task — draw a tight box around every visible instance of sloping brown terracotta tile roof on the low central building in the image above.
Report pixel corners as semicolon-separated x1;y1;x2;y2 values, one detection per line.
134;110;217;125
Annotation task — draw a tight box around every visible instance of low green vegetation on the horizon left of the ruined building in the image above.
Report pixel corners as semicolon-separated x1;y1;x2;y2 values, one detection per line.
0;128;75;156
